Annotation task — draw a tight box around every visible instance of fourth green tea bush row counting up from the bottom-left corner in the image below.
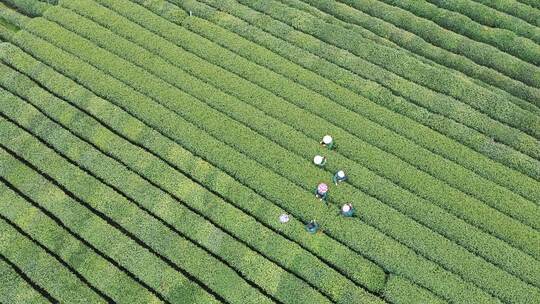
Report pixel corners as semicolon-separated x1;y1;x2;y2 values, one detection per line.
1;142;223;303
